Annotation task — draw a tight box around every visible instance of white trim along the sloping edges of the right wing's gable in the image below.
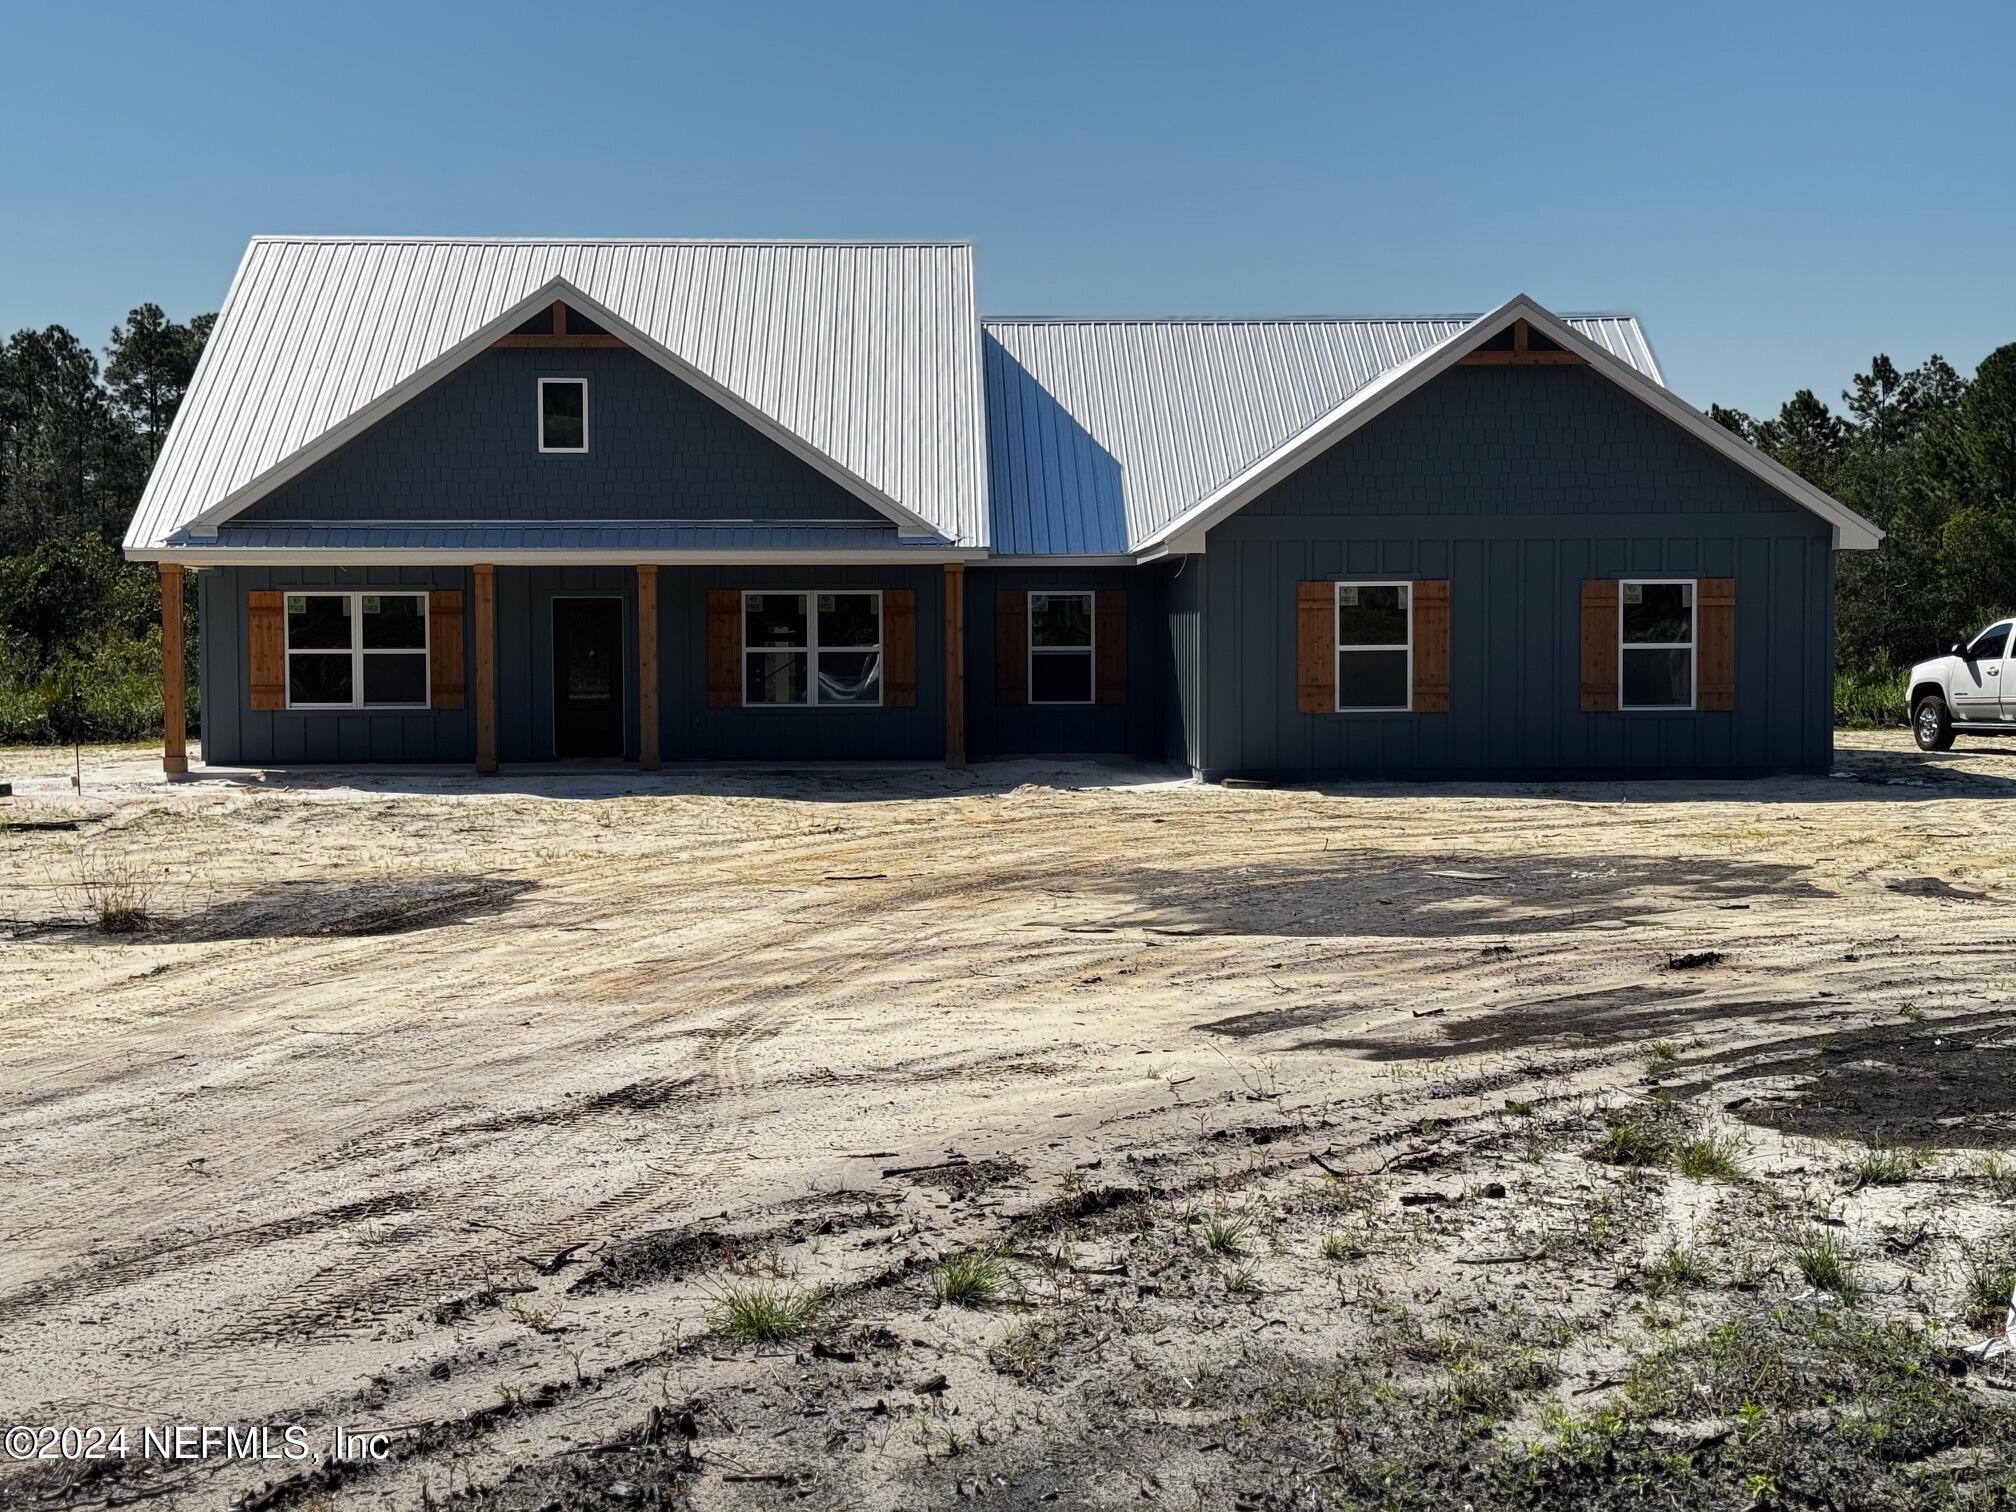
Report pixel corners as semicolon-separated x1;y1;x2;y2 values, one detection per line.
1135;294;1883;562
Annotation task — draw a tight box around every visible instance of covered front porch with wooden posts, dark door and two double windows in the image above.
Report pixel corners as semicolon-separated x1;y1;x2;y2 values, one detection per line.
161;554;968;776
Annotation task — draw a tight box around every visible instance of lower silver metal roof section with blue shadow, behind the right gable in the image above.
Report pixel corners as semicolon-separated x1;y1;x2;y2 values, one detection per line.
980;314;1663;554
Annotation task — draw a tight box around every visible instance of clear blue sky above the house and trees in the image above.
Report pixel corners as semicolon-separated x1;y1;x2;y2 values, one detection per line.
0;0;2016;409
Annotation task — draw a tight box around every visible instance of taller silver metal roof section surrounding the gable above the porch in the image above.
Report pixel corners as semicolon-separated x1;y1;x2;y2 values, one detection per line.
127;236;988;550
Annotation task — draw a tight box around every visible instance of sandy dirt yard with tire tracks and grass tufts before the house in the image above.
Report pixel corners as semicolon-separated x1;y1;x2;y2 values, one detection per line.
0;734;2016;1512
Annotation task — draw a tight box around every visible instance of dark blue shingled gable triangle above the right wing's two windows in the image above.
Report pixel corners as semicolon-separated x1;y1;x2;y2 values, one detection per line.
1218;365;1826;534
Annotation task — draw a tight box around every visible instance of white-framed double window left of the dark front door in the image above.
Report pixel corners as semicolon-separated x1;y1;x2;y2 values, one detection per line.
286;593;427;710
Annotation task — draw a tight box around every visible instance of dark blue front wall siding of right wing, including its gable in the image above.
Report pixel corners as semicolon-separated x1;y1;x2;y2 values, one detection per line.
1198;367;1835;776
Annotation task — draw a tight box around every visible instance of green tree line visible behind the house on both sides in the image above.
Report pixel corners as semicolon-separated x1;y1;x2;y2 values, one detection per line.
0;304;2016;742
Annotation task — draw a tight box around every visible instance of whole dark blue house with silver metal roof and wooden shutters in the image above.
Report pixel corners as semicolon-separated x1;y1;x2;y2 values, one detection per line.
125;238;1881;778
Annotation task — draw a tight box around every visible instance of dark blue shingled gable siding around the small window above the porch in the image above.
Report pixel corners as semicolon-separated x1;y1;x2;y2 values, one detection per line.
237;344;893;530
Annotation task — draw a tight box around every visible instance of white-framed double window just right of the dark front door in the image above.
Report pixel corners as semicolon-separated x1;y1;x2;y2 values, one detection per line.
742;591;881;706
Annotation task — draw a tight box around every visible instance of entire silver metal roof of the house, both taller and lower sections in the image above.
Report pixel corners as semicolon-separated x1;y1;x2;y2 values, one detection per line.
125;236;1881;560
